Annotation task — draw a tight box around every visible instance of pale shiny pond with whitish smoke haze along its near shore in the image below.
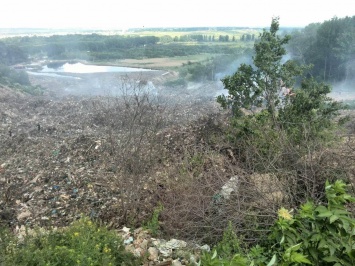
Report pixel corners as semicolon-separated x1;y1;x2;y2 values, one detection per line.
27;62;161;96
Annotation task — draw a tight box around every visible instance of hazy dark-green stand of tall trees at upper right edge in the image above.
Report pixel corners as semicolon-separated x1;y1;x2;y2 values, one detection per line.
288;16;355;82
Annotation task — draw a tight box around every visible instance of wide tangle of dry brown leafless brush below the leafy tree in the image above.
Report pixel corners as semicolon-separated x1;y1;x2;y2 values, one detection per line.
161;115;353;244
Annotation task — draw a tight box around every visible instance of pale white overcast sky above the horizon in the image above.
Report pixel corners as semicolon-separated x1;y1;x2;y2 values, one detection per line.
0;0;355;29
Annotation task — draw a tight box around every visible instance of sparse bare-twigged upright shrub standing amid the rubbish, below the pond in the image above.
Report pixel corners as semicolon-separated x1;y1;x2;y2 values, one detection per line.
89;75;167;225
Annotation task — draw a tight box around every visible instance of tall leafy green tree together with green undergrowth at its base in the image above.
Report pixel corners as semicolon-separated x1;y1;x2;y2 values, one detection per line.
217;18;343;167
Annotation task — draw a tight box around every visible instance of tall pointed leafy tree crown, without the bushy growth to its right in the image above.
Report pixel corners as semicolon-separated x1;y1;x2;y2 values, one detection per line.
217;18;303;124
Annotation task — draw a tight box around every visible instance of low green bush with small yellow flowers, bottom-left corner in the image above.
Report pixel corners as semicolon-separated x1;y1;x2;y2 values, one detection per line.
5;218;140;266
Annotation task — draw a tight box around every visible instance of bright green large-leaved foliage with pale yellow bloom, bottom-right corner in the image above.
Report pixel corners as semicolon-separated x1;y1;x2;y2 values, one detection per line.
201;180;355;266
